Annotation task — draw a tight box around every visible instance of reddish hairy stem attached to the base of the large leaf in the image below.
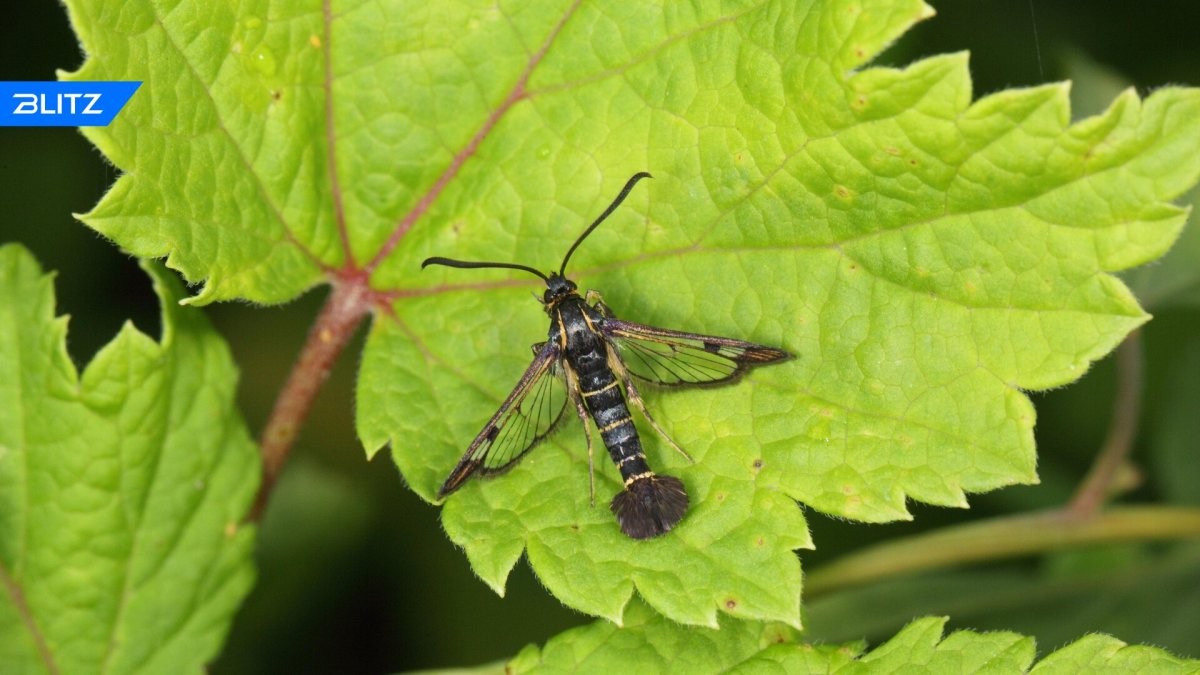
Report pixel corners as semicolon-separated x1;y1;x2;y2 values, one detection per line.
250;279;371;520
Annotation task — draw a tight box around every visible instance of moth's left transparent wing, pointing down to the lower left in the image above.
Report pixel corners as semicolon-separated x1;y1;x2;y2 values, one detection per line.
438;342;566;497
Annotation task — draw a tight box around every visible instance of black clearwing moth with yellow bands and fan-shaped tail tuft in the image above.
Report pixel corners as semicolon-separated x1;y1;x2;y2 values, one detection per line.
421;172;790;539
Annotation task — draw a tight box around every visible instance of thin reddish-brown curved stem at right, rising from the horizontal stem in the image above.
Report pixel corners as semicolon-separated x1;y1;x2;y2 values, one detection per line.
1064;330;1142;519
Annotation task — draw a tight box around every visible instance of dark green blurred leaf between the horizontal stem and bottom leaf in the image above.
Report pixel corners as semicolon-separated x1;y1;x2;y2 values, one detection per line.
804;545;1200;656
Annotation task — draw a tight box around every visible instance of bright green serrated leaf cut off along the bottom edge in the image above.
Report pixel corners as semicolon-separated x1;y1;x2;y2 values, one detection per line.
508;603;1200;675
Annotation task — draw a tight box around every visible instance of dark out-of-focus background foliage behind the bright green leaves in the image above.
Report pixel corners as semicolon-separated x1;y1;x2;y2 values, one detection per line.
0;0;1200;674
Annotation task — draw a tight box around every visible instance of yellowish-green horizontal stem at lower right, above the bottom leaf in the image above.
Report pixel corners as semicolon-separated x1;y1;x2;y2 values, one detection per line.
804;507;1200;593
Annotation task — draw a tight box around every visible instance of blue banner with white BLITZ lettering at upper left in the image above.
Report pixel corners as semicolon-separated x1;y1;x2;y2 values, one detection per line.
0;82;142;126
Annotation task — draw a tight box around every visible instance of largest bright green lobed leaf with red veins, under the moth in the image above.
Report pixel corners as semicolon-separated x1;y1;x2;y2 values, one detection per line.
70;0;1200;626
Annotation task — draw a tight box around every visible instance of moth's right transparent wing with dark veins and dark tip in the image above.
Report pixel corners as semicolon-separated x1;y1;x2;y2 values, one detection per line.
602;318;791;386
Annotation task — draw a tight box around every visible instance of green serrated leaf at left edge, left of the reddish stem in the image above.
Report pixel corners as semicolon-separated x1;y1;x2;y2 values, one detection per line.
0;245;259;673
